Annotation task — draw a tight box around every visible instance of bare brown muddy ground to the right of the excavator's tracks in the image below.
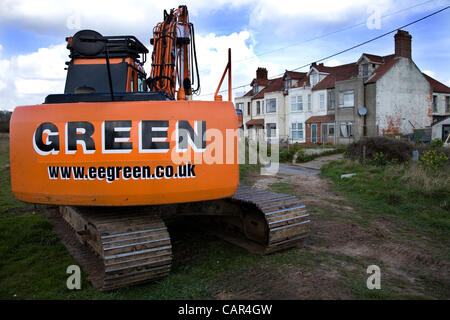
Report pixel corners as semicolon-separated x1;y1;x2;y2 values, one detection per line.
212;165;450;299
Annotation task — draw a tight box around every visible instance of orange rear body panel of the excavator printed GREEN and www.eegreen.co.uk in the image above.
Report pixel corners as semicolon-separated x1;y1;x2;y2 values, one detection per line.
10;101;239;206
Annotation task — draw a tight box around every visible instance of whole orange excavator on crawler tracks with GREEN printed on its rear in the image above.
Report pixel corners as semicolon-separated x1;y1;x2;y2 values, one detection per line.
10;6;310;290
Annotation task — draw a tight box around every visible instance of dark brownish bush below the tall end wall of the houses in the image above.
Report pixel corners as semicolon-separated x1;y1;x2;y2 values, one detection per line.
345;137;414;163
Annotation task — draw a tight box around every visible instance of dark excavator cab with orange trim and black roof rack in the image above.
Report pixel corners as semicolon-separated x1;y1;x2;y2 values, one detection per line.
45;30;167;103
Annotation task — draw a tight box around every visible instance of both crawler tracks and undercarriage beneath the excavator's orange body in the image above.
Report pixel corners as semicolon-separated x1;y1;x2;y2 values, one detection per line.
53;185;310;290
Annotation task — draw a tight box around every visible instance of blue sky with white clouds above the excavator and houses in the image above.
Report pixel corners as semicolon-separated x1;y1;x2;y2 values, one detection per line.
0;0;450;110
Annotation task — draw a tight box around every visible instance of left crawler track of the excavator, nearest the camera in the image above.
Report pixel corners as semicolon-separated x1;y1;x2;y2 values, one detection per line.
60;206;172;290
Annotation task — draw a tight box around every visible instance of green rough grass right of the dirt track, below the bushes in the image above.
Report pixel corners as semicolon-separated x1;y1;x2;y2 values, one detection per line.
322;161;450;244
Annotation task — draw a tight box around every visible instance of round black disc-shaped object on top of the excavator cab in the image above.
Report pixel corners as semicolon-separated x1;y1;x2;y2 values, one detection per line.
72;30;106;57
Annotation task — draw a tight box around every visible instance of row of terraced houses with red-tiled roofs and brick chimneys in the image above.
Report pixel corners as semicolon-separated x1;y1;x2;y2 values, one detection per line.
235;30;450;144
